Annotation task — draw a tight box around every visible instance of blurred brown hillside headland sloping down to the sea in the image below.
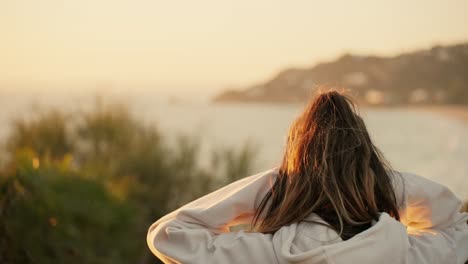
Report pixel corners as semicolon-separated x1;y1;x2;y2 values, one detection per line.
213;43;468;105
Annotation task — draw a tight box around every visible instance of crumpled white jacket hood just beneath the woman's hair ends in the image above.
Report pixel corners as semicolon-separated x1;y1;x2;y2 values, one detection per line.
273;213;407;264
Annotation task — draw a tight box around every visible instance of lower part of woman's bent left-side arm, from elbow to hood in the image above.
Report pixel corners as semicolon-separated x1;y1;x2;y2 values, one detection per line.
148;219;278;264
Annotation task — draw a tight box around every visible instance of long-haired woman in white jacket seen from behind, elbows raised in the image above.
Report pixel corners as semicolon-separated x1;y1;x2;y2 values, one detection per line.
147;91;468;264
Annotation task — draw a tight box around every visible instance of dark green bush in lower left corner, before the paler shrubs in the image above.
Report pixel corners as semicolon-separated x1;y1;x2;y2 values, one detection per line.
1;151;138;264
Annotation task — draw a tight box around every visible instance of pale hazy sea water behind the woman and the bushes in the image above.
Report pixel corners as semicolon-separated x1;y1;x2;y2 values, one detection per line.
0;93;468;200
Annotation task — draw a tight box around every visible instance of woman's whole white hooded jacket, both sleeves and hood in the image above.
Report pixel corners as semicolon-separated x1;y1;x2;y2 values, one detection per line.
147;168;468;264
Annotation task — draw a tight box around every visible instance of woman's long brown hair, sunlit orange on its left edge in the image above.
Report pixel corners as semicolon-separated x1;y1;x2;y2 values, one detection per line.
252;90;400;239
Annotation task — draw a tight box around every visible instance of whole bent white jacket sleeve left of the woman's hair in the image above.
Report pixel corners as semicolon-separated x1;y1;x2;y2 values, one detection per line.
147;169;278;263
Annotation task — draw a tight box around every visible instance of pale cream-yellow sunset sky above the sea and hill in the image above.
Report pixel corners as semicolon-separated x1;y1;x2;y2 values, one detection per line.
0;0;468;95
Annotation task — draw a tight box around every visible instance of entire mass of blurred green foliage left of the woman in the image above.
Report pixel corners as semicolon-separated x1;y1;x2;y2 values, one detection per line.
0;103;254;264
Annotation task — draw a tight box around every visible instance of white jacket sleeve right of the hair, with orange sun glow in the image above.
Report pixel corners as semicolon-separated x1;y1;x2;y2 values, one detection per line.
396;173;468;264
